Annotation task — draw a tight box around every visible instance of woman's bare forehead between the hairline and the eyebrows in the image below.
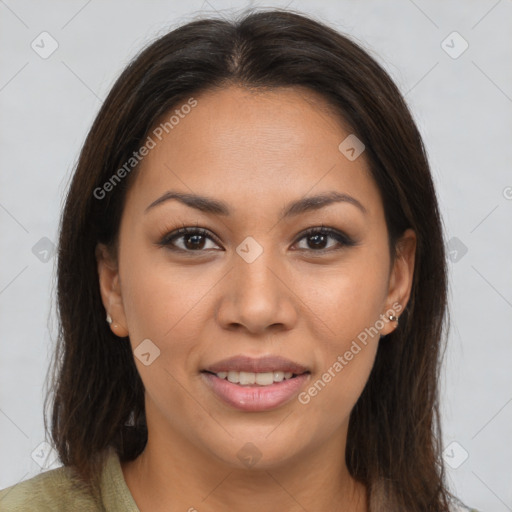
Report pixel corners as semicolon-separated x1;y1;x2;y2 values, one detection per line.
123;86;382;220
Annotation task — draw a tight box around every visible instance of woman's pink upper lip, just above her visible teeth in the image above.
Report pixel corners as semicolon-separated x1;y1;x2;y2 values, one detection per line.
203;355;309;375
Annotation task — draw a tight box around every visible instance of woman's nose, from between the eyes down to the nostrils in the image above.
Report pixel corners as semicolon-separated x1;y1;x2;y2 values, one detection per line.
216;245;298;334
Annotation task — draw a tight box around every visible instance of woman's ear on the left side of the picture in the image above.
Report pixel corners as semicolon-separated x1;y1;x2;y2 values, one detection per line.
96;244;128;338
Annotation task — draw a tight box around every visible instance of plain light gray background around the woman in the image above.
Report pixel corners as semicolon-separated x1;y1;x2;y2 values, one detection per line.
0;0;512;512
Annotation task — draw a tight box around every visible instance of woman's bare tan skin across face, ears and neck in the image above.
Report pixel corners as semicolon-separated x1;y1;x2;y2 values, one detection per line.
97;86;416;512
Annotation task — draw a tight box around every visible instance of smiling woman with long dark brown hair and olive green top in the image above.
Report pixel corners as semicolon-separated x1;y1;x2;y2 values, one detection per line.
0;10;480;512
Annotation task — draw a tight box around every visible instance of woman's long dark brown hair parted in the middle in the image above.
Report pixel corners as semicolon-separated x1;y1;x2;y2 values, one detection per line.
45;9;450;512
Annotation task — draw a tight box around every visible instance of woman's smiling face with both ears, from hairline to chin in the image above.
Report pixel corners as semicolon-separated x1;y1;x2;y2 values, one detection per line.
97;87;415;467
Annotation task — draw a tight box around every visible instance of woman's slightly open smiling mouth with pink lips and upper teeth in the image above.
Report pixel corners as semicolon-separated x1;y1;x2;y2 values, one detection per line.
201;356;311;412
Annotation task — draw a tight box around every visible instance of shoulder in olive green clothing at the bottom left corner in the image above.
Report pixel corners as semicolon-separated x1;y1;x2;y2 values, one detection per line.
0;466;102;512
